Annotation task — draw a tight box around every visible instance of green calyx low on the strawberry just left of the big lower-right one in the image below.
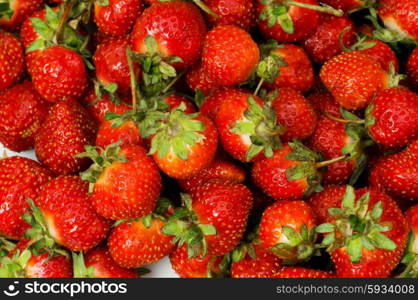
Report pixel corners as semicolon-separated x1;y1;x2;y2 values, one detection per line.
270;224;317;264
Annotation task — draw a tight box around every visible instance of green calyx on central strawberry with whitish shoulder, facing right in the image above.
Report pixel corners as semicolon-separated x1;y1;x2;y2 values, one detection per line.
231;96;283;161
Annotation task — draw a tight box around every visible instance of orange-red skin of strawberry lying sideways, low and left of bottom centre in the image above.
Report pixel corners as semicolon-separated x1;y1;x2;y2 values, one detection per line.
108;219;175;268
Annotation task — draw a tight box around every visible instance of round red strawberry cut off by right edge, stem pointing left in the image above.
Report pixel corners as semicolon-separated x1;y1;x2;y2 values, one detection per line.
366;87;418;147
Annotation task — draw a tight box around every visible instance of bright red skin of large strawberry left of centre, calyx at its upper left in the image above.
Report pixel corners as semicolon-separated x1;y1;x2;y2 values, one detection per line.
91;145;161;220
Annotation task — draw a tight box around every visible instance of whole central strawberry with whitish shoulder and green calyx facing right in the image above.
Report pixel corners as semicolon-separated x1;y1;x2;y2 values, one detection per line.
216;89;283;162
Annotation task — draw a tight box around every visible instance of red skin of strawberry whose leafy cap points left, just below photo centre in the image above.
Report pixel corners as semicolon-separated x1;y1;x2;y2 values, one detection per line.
190;180;253;256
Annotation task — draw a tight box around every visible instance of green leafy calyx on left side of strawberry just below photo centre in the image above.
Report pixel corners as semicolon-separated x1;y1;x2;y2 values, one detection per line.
162;194;216;258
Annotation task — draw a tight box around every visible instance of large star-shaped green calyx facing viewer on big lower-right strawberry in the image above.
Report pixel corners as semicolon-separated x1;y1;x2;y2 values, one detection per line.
316;186;397;263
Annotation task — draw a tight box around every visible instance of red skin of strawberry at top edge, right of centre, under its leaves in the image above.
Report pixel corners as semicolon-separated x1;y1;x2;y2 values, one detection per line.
256;0;319;42
